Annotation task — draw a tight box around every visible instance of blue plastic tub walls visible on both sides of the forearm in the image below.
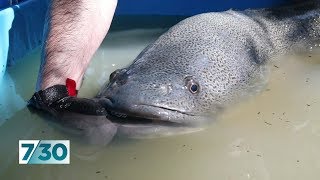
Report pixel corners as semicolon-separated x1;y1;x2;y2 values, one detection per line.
0;0;294;78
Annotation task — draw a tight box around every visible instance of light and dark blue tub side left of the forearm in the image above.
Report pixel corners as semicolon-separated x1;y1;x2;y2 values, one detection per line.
0;0;48;81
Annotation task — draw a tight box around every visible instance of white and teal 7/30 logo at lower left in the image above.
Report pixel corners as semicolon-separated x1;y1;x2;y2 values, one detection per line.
19;140;70;164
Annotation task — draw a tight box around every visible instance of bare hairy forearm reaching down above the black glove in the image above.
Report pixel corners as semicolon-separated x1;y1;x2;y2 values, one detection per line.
37;0;117;90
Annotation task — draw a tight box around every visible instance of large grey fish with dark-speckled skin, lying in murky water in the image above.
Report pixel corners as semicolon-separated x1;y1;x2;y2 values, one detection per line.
98;3;320;129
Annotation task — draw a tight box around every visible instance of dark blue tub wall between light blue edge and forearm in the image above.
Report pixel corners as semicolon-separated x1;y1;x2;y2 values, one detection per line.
7;0;48;66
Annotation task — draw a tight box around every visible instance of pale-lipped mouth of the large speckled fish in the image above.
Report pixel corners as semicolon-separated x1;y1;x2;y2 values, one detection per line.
99;98;196;127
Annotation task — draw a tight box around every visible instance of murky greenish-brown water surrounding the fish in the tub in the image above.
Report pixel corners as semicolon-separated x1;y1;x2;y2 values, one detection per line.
0;29;320;180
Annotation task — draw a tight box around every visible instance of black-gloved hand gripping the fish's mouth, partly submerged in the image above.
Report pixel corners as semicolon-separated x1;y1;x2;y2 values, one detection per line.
28;85;117;145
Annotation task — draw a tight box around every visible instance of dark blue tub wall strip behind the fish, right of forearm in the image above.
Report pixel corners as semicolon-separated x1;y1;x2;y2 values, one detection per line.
116;0;292;16
